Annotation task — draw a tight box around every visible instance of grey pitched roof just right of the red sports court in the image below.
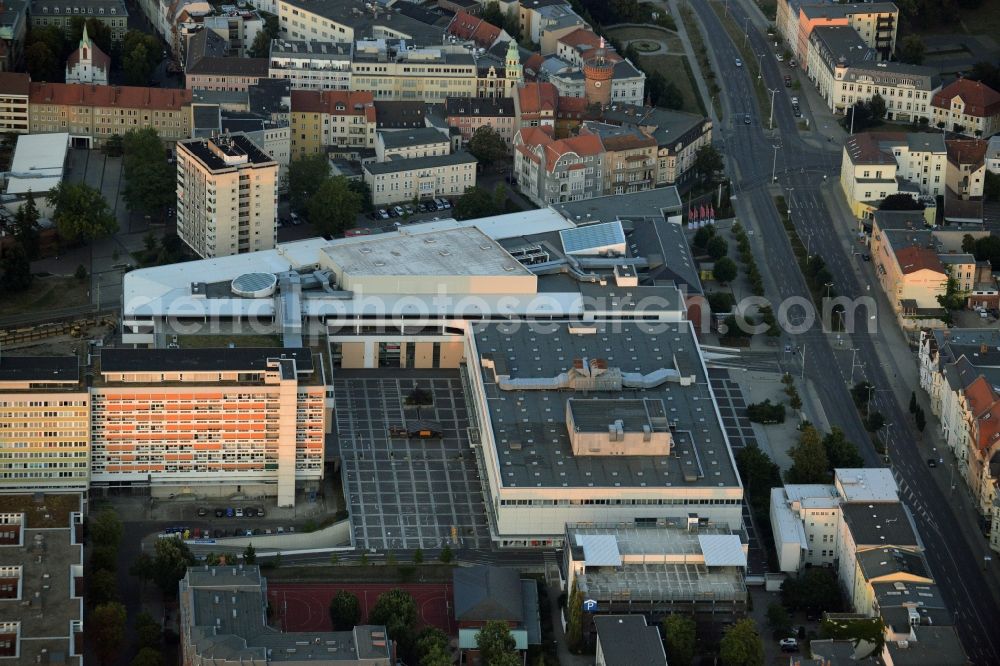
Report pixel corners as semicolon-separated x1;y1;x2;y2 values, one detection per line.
452;566;524;623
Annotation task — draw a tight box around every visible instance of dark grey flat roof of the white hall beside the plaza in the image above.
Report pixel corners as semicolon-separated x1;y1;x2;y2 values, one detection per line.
475;321;740;488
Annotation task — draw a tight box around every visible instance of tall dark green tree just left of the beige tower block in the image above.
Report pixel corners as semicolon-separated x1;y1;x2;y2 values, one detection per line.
122;127;177;215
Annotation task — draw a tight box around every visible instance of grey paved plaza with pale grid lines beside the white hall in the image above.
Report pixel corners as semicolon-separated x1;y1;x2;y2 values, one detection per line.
333;371;490;550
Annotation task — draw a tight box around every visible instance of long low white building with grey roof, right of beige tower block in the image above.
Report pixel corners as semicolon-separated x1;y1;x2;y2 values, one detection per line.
362;151;477;206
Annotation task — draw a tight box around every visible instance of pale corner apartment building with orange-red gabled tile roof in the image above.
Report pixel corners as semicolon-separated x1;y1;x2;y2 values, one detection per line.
514;127;606;206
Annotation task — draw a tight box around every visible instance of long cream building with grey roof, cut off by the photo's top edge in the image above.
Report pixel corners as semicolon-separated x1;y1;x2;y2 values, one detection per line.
278;0;447;46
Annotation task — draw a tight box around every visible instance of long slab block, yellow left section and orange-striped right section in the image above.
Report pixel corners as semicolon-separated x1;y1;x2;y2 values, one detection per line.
0;348;328;506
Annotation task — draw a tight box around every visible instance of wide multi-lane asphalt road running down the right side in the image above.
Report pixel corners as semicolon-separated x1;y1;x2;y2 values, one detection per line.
689;2;1000;664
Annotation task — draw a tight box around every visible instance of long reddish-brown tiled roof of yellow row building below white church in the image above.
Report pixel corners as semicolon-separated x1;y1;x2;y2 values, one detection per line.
29;83;191;111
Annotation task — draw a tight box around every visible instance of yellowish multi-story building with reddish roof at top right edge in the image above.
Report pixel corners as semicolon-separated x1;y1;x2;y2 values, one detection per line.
776;0;899;67
